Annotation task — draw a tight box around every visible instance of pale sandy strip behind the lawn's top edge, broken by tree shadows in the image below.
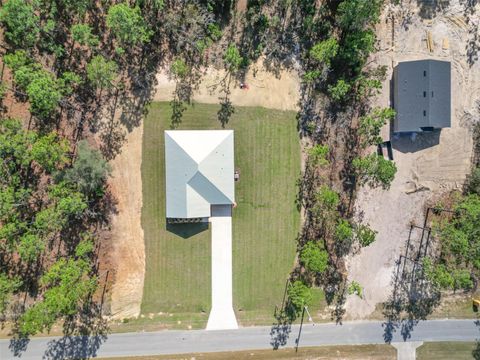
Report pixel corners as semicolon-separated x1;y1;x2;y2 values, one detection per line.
154;60;300;110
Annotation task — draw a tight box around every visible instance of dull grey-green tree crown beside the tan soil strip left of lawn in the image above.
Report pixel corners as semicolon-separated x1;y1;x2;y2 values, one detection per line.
59;140;111;199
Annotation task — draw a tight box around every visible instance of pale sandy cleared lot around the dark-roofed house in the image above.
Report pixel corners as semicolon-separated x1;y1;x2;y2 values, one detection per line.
346;0;480;318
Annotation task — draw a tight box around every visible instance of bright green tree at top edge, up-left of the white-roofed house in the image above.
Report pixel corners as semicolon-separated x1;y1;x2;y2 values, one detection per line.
107;3;153;46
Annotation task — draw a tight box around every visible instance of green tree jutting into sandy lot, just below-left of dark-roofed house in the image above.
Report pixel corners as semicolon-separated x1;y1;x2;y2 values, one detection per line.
352;153;397;189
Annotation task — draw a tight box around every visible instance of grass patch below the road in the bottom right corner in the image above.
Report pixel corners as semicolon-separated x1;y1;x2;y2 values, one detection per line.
417;341;480;360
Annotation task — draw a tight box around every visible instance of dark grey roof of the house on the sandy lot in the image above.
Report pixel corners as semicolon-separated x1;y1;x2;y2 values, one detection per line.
393;60;451;132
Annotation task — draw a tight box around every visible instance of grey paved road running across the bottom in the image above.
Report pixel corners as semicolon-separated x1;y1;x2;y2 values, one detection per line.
0;320;480;360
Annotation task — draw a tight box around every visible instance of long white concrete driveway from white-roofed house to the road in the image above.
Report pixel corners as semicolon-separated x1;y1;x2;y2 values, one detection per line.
207;206;238;330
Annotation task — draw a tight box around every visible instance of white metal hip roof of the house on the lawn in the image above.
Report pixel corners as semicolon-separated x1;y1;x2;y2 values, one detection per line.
165;130;235;218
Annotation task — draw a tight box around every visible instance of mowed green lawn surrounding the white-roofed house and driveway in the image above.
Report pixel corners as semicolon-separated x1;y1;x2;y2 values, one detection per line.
142;103;300;327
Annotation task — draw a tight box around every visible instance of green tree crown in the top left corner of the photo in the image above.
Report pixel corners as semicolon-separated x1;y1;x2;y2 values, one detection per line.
0;0;40;49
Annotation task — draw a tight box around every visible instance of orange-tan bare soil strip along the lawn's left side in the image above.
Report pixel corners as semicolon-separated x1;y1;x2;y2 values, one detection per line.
110;124;145;319
